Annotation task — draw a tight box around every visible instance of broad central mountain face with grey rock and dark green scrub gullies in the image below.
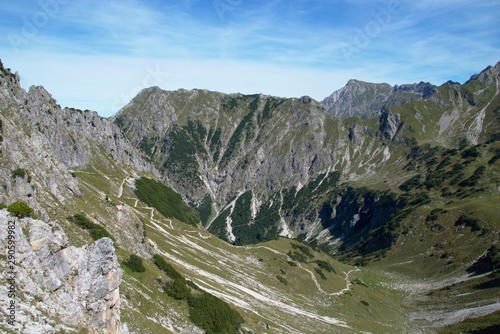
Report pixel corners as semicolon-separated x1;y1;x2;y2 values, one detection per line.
113;88;338;203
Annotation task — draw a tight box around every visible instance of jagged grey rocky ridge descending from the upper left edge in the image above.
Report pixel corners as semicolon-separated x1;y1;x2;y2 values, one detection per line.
0;58;159;207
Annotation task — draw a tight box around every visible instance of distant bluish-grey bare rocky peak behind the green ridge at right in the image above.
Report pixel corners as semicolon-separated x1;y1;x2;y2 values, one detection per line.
322;80;437;118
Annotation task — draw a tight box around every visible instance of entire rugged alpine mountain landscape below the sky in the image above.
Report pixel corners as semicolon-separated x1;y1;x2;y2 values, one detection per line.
0;58;500;333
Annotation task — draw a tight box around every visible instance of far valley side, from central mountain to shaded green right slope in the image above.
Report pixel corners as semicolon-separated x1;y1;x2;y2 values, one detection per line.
114;59;500;328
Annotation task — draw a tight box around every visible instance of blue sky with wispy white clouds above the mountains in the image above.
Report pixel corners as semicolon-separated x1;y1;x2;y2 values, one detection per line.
0;0;500;117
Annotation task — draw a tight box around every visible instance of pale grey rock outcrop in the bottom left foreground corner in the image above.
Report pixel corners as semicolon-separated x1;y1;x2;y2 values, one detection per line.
0;209;128;334
